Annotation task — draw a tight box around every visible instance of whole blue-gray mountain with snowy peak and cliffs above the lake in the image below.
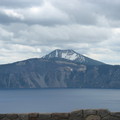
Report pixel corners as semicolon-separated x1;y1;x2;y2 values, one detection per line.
0;50;120;88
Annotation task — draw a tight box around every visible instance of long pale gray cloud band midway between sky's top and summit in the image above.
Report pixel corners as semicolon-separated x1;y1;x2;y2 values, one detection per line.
2;24;112;46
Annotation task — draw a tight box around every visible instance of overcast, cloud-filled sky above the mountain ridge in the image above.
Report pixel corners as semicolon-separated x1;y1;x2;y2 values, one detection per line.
0;0;120;65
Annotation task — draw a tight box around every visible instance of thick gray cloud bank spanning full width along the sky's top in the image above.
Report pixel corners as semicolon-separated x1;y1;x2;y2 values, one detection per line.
0;0;120;26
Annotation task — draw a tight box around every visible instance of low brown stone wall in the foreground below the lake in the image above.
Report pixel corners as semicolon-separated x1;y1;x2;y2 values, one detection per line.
0;109;120;120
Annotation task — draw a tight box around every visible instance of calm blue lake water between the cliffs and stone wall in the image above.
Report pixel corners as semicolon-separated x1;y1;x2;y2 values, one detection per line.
0;89;120;113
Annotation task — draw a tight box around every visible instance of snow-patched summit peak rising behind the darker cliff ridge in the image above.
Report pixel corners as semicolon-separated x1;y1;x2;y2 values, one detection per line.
43;49;103;65
